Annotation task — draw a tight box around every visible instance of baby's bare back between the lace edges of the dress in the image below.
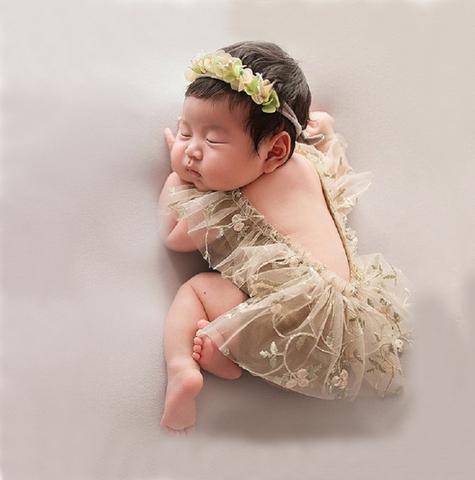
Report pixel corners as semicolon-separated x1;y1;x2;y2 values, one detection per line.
241;153;350;280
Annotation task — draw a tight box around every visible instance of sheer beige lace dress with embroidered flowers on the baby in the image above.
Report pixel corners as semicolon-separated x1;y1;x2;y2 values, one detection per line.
169;136;411;400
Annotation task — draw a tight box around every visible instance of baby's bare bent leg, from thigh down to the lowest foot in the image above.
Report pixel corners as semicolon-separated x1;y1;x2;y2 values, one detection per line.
161;273;246;435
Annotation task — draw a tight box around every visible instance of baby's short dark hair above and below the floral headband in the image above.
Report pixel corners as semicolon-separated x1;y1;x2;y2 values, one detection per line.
185;41;312;158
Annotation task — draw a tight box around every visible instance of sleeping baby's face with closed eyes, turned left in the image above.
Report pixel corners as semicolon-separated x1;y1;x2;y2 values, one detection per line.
171;97;264;191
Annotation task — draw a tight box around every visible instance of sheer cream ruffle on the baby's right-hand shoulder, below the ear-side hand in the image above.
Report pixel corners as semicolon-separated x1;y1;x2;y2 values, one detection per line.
295;134;373;215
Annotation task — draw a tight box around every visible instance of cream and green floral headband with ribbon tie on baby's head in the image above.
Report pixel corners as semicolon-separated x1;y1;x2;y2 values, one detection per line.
185;50;325;145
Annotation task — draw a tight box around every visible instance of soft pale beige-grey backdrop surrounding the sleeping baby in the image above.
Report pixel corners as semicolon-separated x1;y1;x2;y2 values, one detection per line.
0;0;475;480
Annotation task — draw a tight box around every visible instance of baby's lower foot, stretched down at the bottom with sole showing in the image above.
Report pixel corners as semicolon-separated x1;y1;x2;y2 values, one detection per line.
160;368;203;437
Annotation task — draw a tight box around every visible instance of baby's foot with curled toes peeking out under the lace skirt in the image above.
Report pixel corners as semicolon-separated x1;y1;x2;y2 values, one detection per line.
192;320;242;380
